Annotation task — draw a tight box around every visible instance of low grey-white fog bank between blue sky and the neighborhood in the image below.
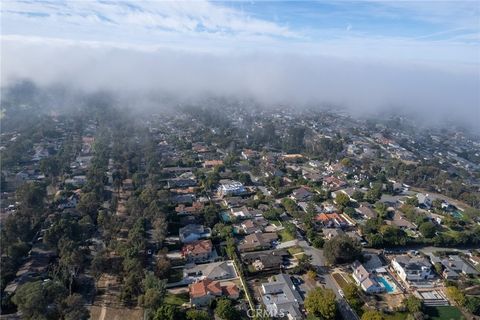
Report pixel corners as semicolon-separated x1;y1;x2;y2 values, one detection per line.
1;40;480;128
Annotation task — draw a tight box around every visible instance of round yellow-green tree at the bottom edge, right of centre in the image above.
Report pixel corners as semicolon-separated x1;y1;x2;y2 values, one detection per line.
305;288;337;320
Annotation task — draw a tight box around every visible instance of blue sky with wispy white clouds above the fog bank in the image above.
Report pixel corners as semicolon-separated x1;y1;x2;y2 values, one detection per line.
1;1;480;68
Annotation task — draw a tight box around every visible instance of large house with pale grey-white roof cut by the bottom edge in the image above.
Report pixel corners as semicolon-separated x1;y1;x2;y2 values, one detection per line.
261;273;303;320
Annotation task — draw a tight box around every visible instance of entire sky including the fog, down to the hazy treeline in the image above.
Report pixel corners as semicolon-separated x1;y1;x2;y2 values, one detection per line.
1;0;480;125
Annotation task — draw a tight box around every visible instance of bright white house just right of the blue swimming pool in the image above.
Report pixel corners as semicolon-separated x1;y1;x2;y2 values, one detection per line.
392;254;434;282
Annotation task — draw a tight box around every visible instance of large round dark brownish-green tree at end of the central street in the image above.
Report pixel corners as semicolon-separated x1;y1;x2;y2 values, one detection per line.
323;235;362;264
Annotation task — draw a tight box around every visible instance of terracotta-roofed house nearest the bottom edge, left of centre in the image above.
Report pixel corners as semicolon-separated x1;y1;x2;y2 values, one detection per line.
188;279;240;307
